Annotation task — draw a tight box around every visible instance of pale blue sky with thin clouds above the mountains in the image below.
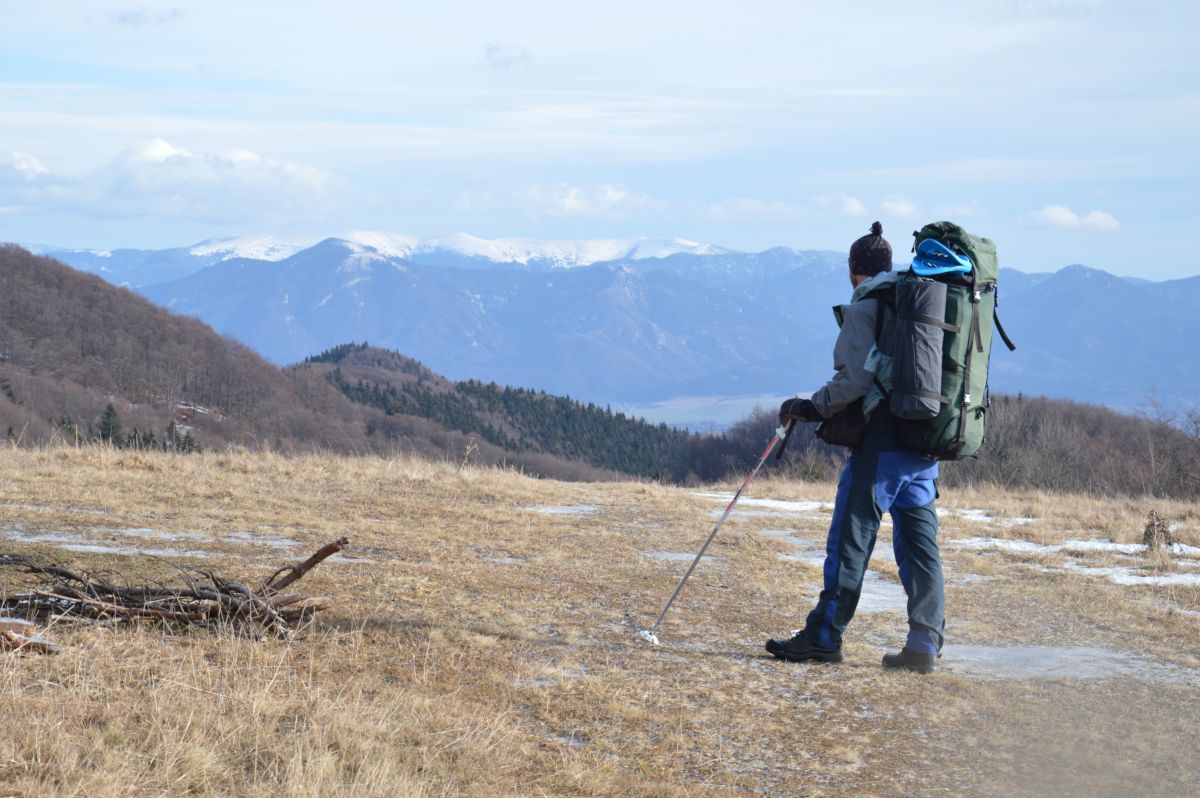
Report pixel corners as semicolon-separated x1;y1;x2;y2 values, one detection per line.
0;0;1200;280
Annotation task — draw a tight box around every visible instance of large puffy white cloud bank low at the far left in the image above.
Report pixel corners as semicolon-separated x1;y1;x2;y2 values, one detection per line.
0;138;341;223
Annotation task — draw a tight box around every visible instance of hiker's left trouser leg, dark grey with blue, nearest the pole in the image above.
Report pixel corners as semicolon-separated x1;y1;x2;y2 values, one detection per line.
804;440;882;648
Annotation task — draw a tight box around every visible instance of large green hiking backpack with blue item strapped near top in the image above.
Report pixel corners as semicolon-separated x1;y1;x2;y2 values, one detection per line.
876;222;1015;460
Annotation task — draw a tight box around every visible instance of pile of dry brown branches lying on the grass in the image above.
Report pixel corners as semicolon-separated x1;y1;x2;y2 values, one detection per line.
0;538;350;636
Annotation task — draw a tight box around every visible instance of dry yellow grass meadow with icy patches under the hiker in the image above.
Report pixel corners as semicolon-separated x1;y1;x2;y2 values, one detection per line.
0;449;1200;797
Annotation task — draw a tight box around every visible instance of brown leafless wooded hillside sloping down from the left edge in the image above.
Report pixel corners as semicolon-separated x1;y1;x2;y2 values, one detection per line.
0;246;616;479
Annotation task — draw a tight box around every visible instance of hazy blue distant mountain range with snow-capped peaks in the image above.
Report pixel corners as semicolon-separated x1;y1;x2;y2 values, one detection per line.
18;233;1200;417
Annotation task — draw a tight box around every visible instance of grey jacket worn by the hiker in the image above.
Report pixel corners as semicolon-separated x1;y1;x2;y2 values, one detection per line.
812;271;896;419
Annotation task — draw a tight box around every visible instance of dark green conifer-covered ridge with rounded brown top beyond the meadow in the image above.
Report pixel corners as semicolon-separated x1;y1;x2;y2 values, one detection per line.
297;343;694;480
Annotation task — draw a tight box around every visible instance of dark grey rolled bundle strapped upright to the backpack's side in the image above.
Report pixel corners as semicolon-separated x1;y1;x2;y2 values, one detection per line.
888;277;958;421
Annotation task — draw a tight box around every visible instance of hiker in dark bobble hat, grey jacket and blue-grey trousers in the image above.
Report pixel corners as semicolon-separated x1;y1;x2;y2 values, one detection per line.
767;222;944;673
